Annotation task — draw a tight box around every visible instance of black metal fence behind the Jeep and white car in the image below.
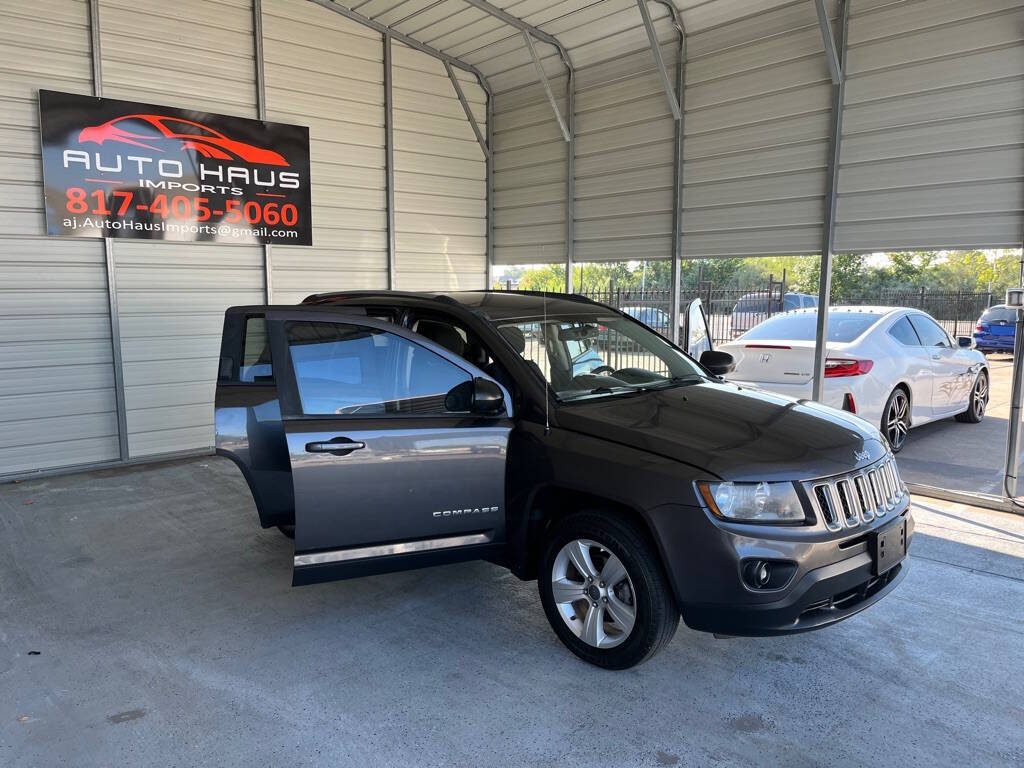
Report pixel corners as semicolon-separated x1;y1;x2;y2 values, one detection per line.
499;276;997;344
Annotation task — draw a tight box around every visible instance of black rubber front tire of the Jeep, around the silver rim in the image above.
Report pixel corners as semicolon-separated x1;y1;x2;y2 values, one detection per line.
538;511;679;670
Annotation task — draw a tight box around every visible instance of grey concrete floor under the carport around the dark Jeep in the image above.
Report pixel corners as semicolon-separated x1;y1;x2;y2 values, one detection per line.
0;459;1024;767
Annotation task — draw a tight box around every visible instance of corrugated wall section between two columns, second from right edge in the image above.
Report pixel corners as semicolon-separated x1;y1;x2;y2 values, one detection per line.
683;0;837;258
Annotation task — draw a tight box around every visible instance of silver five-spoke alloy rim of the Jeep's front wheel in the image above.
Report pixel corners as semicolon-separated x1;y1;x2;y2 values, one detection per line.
551;539;636;648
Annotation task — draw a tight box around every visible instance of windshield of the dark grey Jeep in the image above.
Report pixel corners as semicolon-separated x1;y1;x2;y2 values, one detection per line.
497;312;707;401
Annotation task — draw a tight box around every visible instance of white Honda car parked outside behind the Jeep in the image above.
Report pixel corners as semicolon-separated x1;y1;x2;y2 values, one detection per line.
720;306;988;451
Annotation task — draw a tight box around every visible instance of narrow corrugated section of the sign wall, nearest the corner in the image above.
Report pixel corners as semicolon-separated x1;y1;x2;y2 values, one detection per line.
391;43;487;291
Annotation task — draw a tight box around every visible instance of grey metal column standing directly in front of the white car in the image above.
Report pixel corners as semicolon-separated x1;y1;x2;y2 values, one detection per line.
811;0;850;401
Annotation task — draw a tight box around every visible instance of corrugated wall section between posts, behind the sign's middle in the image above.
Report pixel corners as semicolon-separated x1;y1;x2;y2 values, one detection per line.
100;0;263;458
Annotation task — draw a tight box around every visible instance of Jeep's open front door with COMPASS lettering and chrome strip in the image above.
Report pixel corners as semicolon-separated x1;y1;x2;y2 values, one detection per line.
266;306;512;585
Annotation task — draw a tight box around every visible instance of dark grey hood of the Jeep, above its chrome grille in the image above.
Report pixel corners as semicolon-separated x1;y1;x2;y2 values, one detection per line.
558;382;887;480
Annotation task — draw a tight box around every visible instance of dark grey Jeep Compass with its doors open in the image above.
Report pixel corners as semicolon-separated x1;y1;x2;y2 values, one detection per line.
215;291;913;669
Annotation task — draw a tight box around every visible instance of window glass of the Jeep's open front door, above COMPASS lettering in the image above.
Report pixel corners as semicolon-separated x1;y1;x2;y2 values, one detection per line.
286;322;471;416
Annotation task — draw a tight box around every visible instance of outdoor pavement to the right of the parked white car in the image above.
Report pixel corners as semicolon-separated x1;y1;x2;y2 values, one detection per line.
899;354;1014;496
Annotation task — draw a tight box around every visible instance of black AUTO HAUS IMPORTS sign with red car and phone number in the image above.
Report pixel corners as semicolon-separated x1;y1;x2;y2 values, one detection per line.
39;90;312;246
